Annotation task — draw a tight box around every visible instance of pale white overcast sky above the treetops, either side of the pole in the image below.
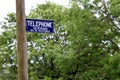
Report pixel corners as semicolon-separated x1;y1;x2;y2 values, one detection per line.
0;0;69;21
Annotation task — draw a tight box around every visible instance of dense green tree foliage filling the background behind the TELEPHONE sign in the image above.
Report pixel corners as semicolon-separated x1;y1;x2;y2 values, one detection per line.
0;0;120;80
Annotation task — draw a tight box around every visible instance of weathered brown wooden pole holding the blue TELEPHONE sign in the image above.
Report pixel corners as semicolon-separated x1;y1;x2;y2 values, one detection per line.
16;0;28;80
